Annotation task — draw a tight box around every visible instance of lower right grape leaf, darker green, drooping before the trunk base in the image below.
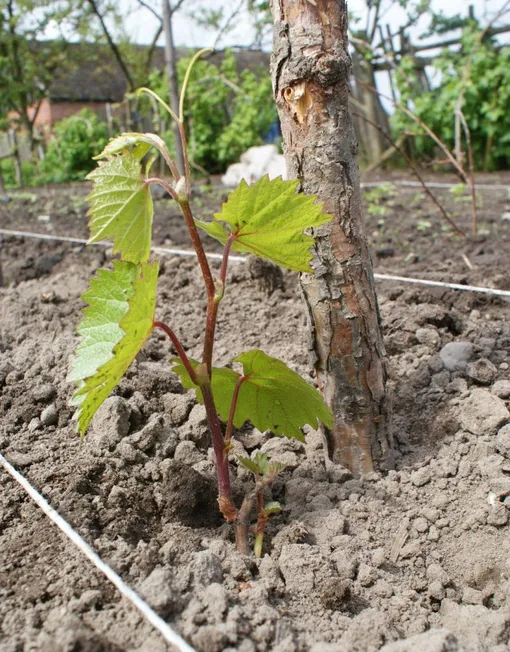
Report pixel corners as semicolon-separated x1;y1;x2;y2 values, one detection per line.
169;350;333;441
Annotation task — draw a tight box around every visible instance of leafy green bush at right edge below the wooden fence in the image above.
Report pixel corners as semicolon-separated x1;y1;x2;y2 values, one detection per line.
392;27;510;170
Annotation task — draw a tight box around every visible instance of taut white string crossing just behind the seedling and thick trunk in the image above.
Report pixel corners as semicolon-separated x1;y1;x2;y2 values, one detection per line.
0;229;510;297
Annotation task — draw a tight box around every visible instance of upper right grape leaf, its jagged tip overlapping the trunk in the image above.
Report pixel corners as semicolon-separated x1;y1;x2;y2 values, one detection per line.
196;176;332;272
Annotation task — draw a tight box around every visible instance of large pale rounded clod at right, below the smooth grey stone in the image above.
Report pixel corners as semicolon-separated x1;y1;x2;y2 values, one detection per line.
459;388;510;435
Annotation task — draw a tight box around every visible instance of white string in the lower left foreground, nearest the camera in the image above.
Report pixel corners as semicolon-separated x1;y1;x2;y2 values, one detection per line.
0;453;196;652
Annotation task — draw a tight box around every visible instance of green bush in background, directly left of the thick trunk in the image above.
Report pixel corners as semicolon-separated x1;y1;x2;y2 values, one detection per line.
150;52;277;172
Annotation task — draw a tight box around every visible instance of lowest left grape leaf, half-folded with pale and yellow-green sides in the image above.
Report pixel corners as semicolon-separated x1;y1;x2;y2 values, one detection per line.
68;261;159;434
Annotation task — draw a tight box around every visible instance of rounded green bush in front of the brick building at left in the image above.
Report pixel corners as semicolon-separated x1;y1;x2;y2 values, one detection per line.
41;109;108;183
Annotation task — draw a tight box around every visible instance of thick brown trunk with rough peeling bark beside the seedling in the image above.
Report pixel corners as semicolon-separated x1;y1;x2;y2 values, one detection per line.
271;0;392;476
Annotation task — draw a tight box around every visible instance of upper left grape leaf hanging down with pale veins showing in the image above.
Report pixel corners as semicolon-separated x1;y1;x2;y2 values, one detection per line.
87;152;154;264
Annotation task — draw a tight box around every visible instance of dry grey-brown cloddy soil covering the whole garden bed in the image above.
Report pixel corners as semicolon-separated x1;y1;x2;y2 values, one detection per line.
0;175;510;652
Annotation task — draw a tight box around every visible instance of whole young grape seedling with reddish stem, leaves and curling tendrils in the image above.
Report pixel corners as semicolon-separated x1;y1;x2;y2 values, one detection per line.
69;53;332;556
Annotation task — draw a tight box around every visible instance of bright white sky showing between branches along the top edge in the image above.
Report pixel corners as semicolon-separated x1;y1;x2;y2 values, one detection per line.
119;0;505;48
